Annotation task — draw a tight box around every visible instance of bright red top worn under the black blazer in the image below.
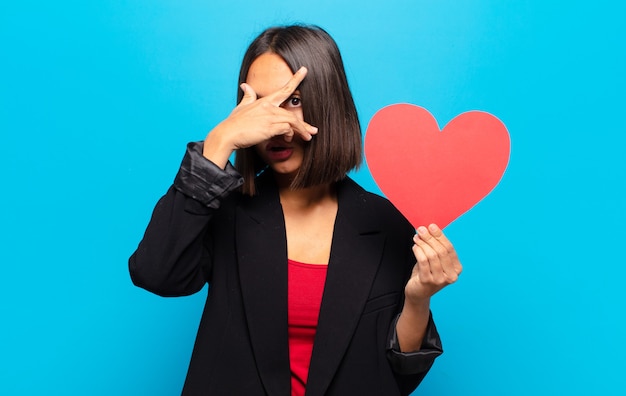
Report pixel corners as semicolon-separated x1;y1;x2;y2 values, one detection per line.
288;260;328;396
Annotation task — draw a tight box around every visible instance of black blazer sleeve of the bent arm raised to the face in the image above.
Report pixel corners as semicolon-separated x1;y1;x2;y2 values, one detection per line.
128;142;243;296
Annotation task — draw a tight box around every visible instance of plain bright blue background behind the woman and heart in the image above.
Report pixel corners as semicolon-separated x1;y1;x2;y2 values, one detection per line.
0;0;626;395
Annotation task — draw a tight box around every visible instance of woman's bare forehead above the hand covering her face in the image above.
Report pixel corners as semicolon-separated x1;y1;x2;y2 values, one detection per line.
246;53;293;97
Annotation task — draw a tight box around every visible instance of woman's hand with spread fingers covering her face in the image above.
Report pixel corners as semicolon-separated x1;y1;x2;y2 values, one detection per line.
203;67;317;168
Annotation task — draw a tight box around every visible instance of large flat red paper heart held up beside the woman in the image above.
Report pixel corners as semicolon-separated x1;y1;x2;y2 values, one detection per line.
365;104;511;228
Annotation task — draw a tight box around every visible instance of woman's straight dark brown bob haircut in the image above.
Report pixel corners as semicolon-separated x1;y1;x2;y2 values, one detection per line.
235;25;362;195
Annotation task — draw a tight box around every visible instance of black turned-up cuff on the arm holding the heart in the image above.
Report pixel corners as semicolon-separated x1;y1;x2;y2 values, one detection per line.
387;314;443;375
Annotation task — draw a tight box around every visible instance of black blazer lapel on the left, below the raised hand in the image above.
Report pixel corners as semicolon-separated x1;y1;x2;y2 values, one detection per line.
235;176;290;395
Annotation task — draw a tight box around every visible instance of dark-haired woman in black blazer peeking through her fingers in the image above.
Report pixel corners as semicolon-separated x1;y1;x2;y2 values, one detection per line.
129;26;461;396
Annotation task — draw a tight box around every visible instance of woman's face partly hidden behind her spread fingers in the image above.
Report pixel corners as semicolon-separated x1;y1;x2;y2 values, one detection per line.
246;53;305;185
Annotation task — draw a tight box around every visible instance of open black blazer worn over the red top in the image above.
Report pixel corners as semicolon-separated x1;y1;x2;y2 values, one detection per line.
129;144;441;396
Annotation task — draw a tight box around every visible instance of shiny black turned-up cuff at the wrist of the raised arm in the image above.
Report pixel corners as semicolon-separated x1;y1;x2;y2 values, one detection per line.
174;142;243;209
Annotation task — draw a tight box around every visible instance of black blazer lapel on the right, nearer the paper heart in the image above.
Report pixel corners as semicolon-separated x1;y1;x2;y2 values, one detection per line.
306;179;384;396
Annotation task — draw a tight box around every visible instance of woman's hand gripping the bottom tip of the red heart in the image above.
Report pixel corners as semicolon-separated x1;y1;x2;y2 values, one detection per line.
405;224;463;304
